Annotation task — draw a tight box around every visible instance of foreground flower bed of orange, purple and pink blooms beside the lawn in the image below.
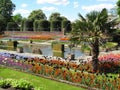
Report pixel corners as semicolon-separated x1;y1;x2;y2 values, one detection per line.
0;54;120;90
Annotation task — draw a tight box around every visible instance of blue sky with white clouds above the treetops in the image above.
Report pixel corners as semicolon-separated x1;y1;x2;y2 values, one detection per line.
11;0;117;21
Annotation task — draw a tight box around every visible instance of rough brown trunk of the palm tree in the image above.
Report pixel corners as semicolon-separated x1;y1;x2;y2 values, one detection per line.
91;38;99;73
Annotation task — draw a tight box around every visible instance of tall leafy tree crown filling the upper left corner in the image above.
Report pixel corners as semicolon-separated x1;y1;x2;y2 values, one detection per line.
0;0;15;28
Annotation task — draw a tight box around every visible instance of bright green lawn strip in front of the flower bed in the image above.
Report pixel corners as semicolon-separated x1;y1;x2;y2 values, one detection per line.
0;67;85;90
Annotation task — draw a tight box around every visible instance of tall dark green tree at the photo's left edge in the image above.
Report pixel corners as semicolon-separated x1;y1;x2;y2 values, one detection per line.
0;0;15;32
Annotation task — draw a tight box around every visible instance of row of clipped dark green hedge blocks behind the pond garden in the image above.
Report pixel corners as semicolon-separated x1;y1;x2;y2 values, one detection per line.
7;19;71;32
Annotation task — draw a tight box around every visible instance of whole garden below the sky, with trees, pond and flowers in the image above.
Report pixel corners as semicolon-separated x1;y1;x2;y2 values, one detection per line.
0;0;120;90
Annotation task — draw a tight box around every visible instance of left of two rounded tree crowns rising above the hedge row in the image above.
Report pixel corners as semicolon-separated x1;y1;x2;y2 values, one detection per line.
28;9;47;21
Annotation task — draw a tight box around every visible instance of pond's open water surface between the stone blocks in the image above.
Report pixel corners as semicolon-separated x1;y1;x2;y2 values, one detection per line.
21;44;85;58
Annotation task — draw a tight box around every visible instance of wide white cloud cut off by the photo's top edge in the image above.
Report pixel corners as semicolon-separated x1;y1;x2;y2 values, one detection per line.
37;0;70;5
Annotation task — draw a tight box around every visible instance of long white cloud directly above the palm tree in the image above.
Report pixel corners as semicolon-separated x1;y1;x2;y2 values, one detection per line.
81;4;115;12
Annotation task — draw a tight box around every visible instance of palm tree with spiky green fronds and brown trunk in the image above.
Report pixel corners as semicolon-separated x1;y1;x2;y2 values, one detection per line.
71;9;114;72
